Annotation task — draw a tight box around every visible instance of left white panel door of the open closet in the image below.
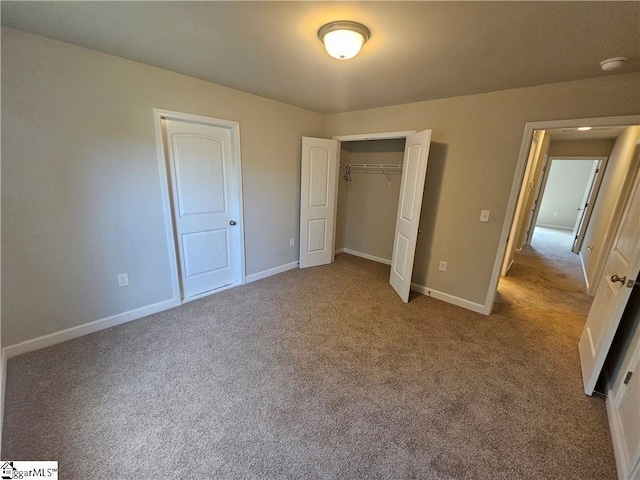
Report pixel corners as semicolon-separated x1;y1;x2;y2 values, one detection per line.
300;137;339;268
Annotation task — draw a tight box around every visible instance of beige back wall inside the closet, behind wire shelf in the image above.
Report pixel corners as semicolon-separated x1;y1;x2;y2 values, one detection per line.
336;140;405;261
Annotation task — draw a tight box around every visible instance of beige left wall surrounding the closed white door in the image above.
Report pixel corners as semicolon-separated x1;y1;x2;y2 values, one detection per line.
2;28;324;345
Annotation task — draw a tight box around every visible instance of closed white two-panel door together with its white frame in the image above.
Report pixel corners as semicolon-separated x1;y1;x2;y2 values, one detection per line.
155;110;245;303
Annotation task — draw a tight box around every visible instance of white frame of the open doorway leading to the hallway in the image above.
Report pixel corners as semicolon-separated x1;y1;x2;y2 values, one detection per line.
481;115;640;315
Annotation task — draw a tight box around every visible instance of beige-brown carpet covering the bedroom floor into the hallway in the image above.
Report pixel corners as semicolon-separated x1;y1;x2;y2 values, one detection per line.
2;232;616;479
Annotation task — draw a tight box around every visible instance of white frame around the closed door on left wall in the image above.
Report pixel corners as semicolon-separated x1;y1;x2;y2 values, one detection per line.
153;108;246;305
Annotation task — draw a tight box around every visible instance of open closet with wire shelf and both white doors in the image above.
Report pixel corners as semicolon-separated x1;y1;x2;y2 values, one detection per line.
300;130;431;302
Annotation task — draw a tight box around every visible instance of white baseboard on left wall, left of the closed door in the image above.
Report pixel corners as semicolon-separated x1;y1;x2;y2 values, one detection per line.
2;298;180;359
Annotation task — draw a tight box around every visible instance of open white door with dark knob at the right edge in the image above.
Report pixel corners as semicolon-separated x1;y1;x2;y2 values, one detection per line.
579;167;640;395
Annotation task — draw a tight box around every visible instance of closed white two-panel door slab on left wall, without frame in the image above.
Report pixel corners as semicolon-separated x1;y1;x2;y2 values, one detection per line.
163;120;242;299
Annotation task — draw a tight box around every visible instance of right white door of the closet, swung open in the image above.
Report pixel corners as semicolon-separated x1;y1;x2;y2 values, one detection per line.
389;130;431;303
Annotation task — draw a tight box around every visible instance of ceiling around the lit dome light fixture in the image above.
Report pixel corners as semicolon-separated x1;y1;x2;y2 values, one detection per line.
1;1;640;113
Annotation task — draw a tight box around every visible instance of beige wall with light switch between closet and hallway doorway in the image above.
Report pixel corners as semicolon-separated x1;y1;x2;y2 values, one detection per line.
326;74;640;304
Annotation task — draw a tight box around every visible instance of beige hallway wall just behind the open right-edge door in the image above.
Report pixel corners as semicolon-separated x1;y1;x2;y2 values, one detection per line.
580;126;640;294
